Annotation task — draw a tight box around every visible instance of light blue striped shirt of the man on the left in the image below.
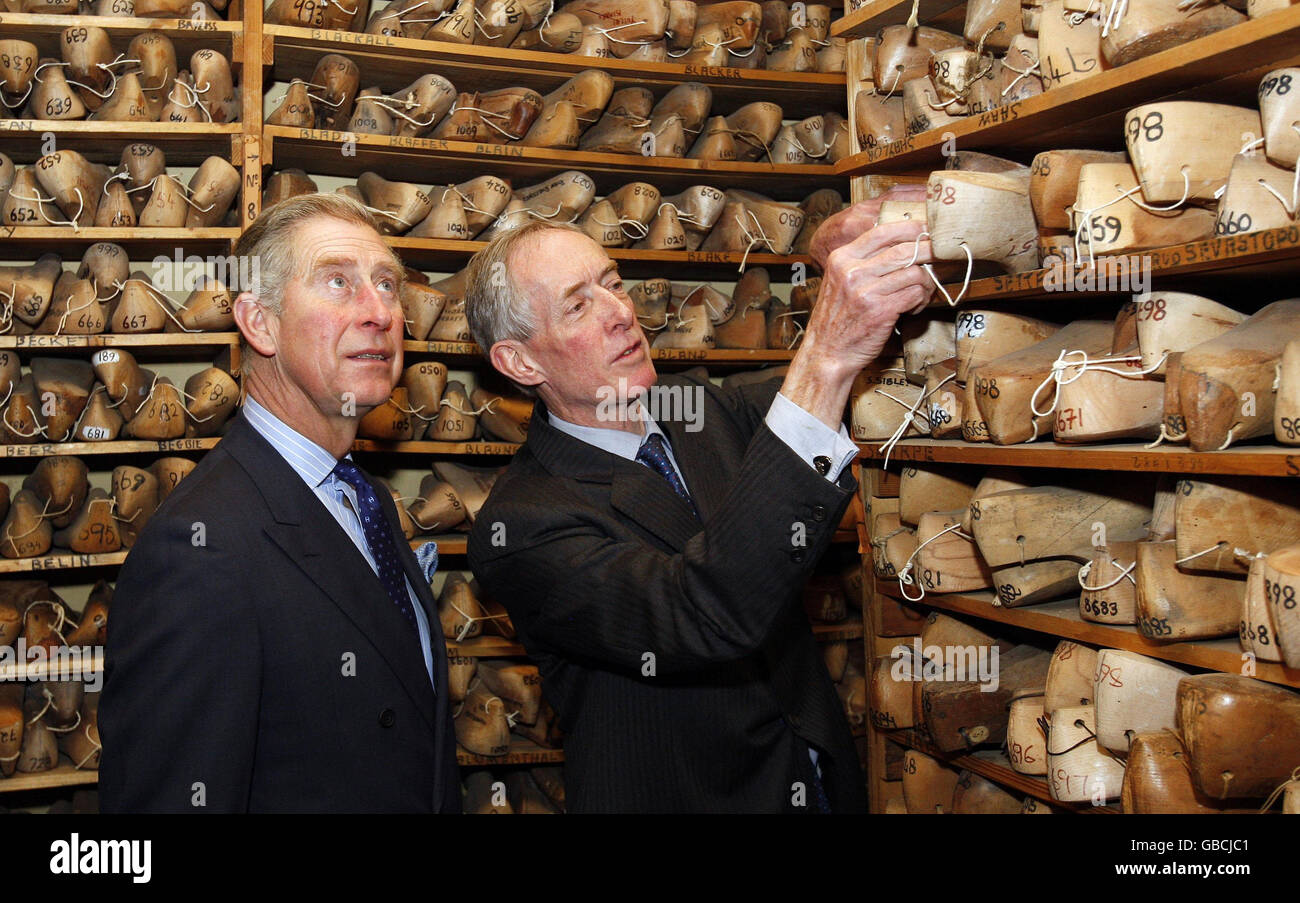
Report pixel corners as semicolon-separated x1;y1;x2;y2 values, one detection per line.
243;395;433;683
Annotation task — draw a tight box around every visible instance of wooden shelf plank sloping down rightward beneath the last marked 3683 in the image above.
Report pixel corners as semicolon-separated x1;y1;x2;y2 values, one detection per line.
876;581;1300;687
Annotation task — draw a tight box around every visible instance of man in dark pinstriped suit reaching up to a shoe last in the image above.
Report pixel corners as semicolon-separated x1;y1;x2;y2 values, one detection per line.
465;194;931;812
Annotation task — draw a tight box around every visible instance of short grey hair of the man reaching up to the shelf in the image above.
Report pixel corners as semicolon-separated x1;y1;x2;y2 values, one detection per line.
465;220;586;355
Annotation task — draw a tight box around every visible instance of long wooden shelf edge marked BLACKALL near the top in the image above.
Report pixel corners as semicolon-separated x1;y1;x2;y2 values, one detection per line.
263;25;845;118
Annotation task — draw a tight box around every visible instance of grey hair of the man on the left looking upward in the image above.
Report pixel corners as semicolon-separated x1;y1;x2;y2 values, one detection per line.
235;194;404;314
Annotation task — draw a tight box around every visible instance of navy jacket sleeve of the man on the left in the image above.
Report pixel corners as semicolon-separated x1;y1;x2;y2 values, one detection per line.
99;515;261;812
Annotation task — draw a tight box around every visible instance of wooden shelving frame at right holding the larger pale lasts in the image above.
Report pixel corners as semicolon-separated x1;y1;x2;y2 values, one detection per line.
847;0;1300;812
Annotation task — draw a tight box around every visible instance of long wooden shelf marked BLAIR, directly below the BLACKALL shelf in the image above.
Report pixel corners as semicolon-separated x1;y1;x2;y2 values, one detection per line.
263;126;844;201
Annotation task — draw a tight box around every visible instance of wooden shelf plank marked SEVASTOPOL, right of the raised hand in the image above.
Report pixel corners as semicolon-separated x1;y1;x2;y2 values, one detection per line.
931;224;1300;307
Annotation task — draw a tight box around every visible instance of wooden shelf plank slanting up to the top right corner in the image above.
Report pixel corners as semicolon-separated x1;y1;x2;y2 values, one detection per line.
832;7;1300;175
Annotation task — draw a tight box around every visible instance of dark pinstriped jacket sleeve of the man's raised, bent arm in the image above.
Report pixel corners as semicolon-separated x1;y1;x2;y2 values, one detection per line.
469;423;854;677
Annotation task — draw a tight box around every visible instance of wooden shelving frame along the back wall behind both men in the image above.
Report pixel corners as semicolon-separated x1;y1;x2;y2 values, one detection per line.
0;4;862;793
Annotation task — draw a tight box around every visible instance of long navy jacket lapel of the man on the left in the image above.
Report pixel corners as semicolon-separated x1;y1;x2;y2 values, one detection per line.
221;418;437;728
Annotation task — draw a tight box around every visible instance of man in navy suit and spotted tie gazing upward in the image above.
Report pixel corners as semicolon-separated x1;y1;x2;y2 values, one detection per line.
99;195;460;812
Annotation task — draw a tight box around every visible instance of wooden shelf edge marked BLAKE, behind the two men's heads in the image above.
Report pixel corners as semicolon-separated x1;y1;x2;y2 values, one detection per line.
386;235;813;282
